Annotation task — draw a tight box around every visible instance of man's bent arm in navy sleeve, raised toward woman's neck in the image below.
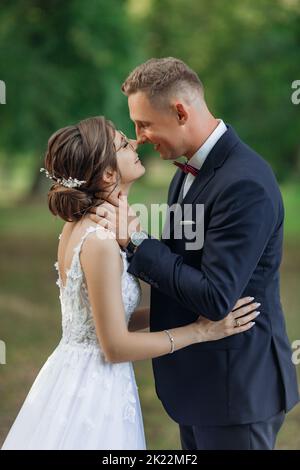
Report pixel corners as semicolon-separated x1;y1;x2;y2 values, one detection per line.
128;180;276;320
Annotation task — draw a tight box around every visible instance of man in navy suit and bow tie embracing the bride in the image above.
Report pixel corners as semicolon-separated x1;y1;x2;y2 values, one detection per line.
95;57;298;450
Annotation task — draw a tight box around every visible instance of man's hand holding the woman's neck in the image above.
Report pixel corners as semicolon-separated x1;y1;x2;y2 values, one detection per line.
89;192;141;248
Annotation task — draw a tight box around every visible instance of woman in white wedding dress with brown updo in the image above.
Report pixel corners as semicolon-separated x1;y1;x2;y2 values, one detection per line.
2;117;255;450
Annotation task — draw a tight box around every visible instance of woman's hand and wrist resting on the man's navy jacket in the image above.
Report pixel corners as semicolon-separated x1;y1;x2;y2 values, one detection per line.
195;297;260;342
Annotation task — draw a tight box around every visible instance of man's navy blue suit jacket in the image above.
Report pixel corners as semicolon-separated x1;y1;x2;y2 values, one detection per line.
128;126;298;425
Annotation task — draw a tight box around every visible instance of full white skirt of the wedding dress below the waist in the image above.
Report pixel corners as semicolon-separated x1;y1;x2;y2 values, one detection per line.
2;341;146;450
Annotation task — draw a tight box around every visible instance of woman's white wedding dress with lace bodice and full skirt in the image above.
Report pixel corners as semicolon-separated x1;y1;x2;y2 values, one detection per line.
2;226;146;450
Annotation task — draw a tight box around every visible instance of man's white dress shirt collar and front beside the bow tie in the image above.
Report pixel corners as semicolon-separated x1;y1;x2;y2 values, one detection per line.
183;119;227;197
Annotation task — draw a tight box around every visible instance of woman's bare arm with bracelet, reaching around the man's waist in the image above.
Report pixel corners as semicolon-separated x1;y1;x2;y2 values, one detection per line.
80;235;255;363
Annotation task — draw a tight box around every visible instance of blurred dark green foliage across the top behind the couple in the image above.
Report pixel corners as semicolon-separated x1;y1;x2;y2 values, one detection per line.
0;0;300;198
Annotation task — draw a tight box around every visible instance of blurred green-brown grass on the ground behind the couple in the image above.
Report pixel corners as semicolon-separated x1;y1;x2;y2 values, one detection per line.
0;182;300;449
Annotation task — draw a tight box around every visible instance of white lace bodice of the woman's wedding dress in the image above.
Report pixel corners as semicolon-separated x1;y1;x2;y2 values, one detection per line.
54;226;141;350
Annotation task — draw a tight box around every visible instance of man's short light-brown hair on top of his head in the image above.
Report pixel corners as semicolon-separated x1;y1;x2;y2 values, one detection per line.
122;57;204;102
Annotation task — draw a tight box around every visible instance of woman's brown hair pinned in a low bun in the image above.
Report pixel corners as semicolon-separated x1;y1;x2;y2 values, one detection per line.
45;116;118;222
